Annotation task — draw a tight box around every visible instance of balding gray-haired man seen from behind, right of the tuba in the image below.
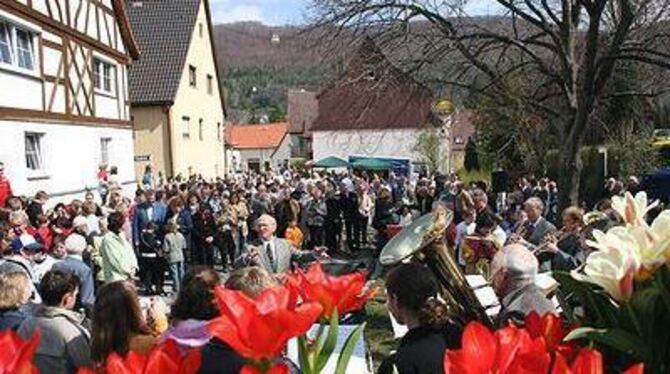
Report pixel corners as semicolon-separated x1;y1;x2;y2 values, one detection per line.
491;244;556;326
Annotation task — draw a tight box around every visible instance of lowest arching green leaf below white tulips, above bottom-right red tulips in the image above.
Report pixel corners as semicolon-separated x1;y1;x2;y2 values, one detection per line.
564;327;649;361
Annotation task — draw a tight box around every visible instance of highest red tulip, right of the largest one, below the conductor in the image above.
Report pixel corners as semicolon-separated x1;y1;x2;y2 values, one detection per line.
289;262;374;318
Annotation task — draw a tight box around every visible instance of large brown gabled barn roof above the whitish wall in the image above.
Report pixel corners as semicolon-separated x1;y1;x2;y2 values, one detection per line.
312;38;433;131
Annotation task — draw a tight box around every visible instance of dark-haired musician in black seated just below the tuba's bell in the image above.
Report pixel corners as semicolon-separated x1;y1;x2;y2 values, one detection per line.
377;263;462;374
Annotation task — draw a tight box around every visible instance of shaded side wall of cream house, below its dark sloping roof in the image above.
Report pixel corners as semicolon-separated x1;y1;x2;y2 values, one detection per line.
130;106;172;178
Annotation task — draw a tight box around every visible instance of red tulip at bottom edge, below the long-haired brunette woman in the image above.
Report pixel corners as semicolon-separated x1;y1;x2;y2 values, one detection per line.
77;340;201;374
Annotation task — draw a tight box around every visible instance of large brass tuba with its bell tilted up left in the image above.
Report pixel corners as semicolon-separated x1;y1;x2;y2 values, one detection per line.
379;207;493;327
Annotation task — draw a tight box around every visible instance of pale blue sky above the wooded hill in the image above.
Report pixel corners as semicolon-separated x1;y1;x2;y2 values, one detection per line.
210;0;504;26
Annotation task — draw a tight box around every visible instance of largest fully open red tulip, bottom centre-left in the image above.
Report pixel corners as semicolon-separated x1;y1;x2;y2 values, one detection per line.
209;287;322;361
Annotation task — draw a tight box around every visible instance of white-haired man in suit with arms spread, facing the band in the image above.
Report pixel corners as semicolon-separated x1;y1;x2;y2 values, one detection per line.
235;214;327;274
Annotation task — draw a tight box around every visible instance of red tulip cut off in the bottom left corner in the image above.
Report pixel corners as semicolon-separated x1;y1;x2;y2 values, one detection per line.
0;330;40;374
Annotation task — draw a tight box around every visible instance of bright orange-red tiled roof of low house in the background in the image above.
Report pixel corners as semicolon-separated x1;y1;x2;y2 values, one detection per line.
226;122;288;149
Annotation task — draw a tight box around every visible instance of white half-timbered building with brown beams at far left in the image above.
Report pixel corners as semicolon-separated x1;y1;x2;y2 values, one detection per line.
0;0;139;199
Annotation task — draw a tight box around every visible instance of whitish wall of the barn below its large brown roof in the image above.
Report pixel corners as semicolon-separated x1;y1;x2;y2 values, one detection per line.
312;129;421;161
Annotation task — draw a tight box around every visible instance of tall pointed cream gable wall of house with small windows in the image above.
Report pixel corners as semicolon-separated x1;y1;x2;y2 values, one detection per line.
172;2;225;178
